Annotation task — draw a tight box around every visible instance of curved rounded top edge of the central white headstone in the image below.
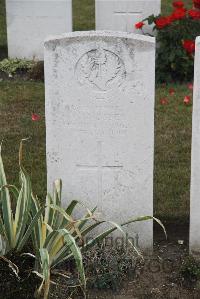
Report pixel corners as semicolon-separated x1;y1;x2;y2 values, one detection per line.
45;30;155;45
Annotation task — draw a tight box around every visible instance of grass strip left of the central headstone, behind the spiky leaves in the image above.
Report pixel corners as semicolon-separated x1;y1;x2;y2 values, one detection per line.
0;81;46;197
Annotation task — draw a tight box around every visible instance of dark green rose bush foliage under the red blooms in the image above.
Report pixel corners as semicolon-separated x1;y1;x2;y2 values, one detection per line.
156;19;197;82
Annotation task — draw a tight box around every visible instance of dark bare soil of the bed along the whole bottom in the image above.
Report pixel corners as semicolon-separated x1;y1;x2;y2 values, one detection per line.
0;224;200;299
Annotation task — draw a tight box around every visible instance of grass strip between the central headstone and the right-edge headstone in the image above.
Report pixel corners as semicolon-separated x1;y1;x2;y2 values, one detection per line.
154;85;192;219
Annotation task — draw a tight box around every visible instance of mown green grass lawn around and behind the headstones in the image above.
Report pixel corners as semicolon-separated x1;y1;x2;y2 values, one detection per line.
0;0;195;220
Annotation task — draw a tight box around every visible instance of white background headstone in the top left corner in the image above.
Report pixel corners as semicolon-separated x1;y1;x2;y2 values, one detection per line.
6;0;72;60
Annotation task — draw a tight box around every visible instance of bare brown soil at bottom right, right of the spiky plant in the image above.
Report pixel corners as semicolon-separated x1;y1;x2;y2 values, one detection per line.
85;224;200;299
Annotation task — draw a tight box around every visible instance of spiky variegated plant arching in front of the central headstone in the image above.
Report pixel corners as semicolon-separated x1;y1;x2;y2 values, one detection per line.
32;180;164;299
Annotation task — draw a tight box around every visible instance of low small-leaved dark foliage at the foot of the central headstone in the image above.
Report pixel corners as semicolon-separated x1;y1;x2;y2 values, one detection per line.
83;242;137;291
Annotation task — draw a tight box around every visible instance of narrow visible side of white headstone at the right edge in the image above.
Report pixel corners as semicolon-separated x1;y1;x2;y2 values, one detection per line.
190;37;200;257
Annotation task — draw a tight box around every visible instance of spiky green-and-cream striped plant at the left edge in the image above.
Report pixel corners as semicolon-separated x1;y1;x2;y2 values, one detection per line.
0;140;43;255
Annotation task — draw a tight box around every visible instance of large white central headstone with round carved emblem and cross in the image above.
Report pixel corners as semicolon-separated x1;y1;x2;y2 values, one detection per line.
45;31;155;248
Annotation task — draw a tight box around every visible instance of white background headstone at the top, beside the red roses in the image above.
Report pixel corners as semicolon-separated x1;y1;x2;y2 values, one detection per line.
96;0;161;34
